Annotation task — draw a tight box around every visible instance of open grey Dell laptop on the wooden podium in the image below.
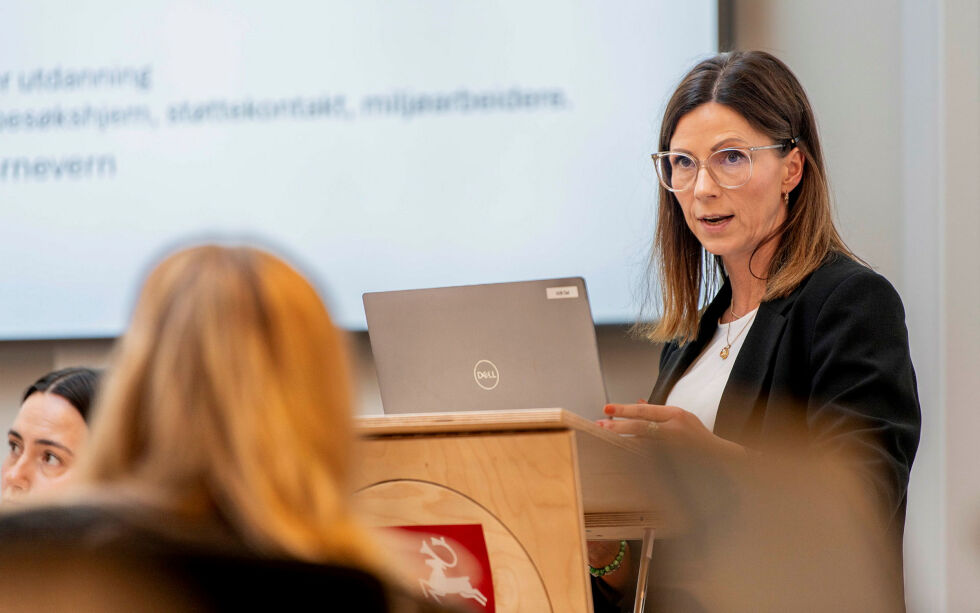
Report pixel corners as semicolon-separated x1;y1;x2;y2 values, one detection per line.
364;277;606;419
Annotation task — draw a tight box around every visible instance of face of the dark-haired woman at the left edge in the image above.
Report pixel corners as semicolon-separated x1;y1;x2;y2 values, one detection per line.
2;392;88;503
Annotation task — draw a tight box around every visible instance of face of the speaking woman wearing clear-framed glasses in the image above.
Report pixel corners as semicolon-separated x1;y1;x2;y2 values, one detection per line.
670;102;803;274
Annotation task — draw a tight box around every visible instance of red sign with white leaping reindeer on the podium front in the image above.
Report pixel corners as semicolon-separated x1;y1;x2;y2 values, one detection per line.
397;524;496;613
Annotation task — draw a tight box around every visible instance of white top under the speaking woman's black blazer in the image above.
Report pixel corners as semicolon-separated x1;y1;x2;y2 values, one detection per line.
667;307;759;430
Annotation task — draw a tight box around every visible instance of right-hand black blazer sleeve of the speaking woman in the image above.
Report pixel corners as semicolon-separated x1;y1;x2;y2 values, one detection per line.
807;270;921;520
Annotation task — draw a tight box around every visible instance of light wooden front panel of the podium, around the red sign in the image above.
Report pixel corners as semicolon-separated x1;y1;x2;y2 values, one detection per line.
355;430;592;613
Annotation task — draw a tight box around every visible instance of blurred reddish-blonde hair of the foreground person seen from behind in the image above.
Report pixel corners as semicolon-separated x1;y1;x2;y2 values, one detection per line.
76;246;372;566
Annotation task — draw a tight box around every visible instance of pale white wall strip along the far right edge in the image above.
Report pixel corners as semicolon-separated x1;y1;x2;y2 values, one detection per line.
936;0;980;611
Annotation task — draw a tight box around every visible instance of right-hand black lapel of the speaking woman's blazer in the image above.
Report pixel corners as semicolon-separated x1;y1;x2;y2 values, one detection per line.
714;288;800;441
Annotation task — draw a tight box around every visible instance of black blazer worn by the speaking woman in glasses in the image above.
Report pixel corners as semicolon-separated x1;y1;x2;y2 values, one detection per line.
650;255;921;534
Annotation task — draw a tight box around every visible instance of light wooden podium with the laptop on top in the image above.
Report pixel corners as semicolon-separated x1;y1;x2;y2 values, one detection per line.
354;409;679;613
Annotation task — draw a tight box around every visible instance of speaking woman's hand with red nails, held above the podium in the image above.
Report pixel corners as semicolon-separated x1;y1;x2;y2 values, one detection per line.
596;401;745;458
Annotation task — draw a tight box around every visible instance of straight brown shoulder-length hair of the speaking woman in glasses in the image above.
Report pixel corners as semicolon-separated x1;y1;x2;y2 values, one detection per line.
643;51;854;343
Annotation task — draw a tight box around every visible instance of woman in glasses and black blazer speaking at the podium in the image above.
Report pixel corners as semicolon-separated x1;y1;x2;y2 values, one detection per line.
589;51;920;610
